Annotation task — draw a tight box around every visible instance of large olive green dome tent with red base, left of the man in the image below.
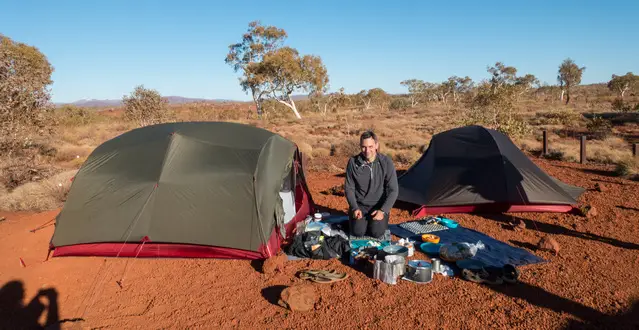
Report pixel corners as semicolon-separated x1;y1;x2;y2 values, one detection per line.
51;122;312;259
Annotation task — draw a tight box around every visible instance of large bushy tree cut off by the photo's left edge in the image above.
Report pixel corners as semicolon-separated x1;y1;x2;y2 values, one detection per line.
0;34;53;150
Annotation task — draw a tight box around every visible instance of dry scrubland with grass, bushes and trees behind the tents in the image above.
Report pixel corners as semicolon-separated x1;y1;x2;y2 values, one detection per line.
0;22;639;210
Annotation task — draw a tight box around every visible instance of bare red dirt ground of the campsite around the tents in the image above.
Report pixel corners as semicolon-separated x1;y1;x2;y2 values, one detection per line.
0;160;639;329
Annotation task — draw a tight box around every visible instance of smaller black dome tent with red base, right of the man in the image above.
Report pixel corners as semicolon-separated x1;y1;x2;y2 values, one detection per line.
398;126;584;217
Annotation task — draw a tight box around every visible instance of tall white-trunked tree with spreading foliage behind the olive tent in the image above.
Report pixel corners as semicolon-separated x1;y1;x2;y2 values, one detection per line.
225;21;329;119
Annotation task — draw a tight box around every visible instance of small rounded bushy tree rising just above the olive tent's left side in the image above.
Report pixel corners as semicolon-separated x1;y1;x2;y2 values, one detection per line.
122;85;169;126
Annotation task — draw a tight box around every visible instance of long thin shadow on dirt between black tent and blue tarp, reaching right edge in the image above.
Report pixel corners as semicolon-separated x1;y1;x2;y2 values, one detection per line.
478;213;639;250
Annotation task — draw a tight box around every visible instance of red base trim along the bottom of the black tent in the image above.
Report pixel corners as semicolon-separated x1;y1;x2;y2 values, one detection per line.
413;204;575;218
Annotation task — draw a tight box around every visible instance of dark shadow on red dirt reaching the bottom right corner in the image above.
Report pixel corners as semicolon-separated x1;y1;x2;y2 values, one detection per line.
486;282;639;329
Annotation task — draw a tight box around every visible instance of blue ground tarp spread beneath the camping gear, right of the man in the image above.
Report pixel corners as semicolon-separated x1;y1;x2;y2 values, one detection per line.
388;225;546;267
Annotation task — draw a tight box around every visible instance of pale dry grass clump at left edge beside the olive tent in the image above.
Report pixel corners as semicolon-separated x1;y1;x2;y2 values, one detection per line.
0;170;77;211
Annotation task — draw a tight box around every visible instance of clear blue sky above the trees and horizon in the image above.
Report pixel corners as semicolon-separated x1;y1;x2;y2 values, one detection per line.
0;0;639;102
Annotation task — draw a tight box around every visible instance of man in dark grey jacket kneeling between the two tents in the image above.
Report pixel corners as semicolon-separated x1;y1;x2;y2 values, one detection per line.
344;131;398;238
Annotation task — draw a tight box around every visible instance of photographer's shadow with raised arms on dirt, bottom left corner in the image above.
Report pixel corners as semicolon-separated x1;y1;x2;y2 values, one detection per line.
0;281;63;329
